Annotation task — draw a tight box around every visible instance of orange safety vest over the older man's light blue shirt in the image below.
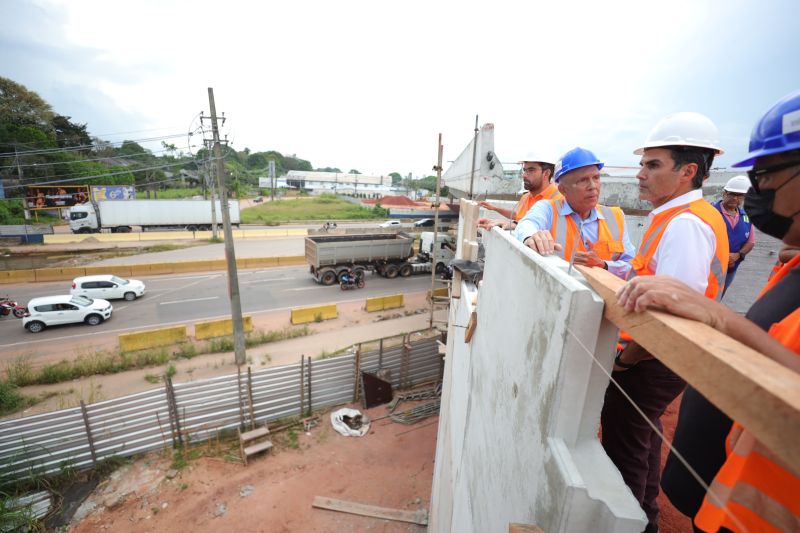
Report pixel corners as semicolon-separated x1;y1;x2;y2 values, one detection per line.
548;198;625;261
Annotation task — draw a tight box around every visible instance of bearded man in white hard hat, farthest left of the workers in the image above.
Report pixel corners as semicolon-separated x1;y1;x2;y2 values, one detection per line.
478;152;561;230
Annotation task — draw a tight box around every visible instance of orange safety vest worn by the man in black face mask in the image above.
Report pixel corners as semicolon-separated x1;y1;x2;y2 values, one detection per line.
694;256;800;533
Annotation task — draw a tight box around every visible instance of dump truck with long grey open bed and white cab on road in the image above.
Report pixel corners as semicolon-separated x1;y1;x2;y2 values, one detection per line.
305;232;455;285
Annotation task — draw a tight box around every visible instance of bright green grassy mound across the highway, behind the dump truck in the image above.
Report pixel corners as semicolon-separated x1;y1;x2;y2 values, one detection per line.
241;194;386;224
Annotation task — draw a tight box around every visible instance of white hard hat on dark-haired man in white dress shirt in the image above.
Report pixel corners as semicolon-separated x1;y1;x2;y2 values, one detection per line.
633;111;725;155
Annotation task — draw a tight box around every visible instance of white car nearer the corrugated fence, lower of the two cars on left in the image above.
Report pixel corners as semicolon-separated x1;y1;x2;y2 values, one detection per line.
22;294;114;333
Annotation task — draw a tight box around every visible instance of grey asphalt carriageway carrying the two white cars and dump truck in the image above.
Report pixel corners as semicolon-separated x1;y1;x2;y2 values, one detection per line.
0;267;438;350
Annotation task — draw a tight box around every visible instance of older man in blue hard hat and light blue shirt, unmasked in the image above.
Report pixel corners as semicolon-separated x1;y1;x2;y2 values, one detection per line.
516;148;634;279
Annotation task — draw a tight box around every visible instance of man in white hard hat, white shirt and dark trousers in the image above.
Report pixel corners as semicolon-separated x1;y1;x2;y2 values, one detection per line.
601;113;728;533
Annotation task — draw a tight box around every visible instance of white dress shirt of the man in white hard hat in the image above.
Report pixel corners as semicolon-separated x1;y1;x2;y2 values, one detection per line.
648;189;717;293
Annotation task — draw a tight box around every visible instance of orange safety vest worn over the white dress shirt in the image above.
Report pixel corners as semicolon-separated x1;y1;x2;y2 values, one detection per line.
630;199;729;300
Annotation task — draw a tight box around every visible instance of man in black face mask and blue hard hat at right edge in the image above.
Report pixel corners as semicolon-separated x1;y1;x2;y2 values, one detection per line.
620;91;800;533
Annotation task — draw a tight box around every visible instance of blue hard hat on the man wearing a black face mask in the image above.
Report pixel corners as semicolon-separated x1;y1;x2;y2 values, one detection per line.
733;90;800;167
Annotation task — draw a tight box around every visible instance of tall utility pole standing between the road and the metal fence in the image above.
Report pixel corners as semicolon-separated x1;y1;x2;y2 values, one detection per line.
208;87;246;365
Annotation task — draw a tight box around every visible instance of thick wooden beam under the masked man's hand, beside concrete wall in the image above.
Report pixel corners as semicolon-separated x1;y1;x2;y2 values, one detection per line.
575;265;800;472
